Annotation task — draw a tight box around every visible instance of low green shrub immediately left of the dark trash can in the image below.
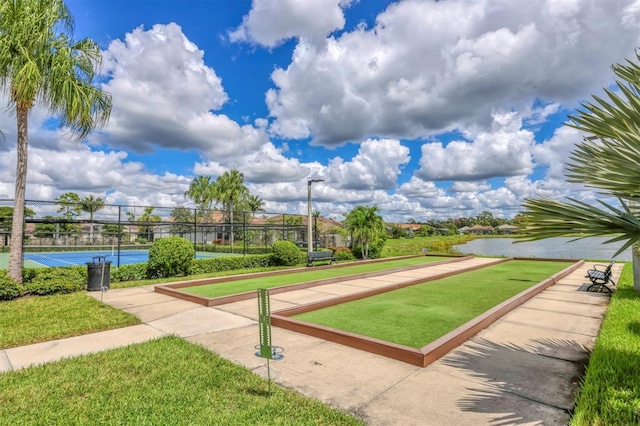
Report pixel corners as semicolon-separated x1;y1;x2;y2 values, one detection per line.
25;266;87;296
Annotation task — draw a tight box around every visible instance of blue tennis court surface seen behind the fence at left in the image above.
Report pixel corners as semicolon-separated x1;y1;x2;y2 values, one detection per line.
24;250;238;267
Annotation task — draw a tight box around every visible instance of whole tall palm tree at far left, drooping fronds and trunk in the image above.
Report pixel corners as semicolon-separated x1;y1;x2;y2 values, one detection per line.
0;0;111;282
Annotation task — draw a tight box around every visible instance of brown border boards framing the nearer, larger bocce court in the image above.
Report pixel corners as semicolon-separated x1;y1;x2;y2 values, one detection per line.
271;259;584;367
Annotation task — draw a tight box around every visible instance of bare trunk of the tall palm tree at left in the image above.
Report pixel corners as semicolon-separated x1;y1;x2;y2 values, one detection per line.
8;106;29;283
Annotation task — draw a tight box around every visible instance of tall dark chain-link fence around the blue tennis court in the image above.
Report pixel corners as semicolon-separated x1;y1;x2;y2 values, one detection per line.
0;200;343;269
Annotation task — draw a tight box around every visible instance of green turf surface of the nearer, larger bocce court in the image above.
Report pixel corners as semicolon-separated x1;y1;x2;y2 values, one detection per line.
294;260;571;349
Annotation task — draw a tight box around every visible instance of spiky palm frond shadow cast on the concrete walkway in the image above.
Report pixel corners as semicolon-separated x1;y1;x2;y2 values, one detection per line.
442;339;589;425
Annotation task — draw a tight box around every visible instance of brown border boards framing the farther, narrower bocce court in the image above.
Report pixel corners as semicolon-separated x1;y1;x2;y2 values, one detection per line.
154;255;473;307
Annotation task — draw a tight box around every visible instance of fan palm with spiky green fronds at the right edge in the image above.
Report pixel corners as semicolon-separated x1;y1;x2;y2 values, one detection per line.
522;50;640;290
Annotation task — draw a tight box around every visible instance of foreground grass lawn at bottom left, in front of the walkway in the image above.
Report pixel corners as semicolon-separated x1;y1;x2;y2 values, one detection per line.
0;336;363;426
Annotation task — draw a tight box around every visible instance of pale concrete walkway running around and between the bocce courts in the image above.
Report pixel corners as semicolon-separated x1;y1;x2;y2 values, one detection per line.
0;259;622;425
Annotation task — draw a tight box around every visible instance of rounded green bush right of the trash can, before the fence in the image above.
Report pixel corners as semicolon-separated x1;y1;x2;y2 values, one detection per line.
147;237;195;278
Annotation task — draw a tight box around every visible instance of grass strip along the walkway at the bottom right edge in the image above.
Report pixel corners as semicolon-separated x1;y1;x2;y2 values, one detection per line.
570;262;640;426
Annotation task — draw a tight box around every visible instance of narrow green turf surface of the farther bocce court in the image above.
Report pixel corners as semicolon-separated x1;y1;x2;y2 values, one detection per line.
180;256;450;297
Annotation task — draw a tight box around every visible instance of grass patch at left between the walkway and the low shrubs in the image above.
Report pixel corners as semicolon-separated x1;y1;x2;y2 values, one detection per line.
0;292;140;349
